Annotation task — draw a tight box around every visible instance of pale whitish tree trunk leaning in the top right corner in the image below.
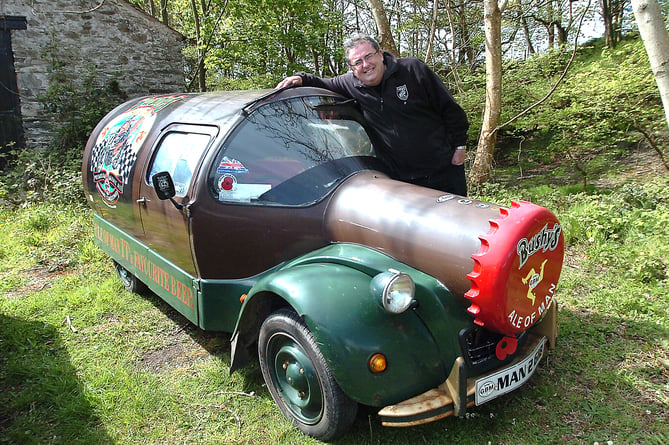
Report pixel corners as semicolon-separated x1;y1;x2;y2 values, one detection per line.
632;0;669;125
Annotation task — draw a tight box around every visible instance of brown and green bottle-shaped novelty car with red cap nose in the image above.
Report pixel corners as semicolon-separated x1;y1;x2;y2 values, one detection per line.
82;88;564;440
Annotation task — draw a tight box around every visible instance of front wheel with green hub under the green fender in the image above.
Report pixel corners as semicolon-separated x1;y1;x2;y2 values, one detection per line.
258;310;358;441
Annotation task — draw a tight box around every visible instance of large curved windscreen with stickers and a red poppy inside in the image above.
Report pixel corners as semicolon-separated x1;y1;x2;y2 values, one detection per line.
209;96;374;205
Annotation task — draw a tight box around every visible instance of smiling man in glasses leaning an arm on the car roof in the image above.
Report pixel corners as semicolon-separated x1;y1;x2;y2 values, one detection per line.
276;34;469;196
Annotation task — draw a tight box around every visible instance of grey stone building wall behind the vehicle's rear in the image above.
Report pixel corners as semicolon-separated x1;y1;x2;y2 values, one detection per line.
0;0;184;152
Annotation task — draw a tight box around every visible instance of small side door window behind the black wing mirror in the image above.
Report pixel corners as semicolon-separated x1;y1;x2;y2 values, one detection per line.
146;131;211;196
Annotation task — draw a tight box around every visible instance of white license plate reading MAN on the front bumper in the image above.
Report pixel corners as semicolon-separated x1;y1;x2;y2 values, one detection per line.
476;337;546;405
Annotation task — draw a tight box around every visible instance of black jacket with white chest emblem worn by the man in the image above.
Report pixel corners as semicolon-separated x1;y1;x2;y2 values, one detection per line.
298;53;469;180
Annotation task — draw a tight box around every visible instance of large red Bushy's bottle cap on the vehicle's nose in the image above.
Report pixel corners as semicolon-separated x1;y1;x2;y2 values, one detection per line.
465;201;564;332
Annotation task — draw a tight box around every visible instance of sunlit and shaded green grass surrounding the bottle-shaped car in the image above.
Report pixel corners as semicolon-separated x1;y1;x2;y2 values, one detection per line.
0;157;669;445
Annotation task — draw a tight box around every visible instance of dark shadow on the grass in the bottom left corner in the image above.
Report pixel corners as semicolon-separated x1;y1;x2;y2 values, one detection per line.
0;314;113;444
